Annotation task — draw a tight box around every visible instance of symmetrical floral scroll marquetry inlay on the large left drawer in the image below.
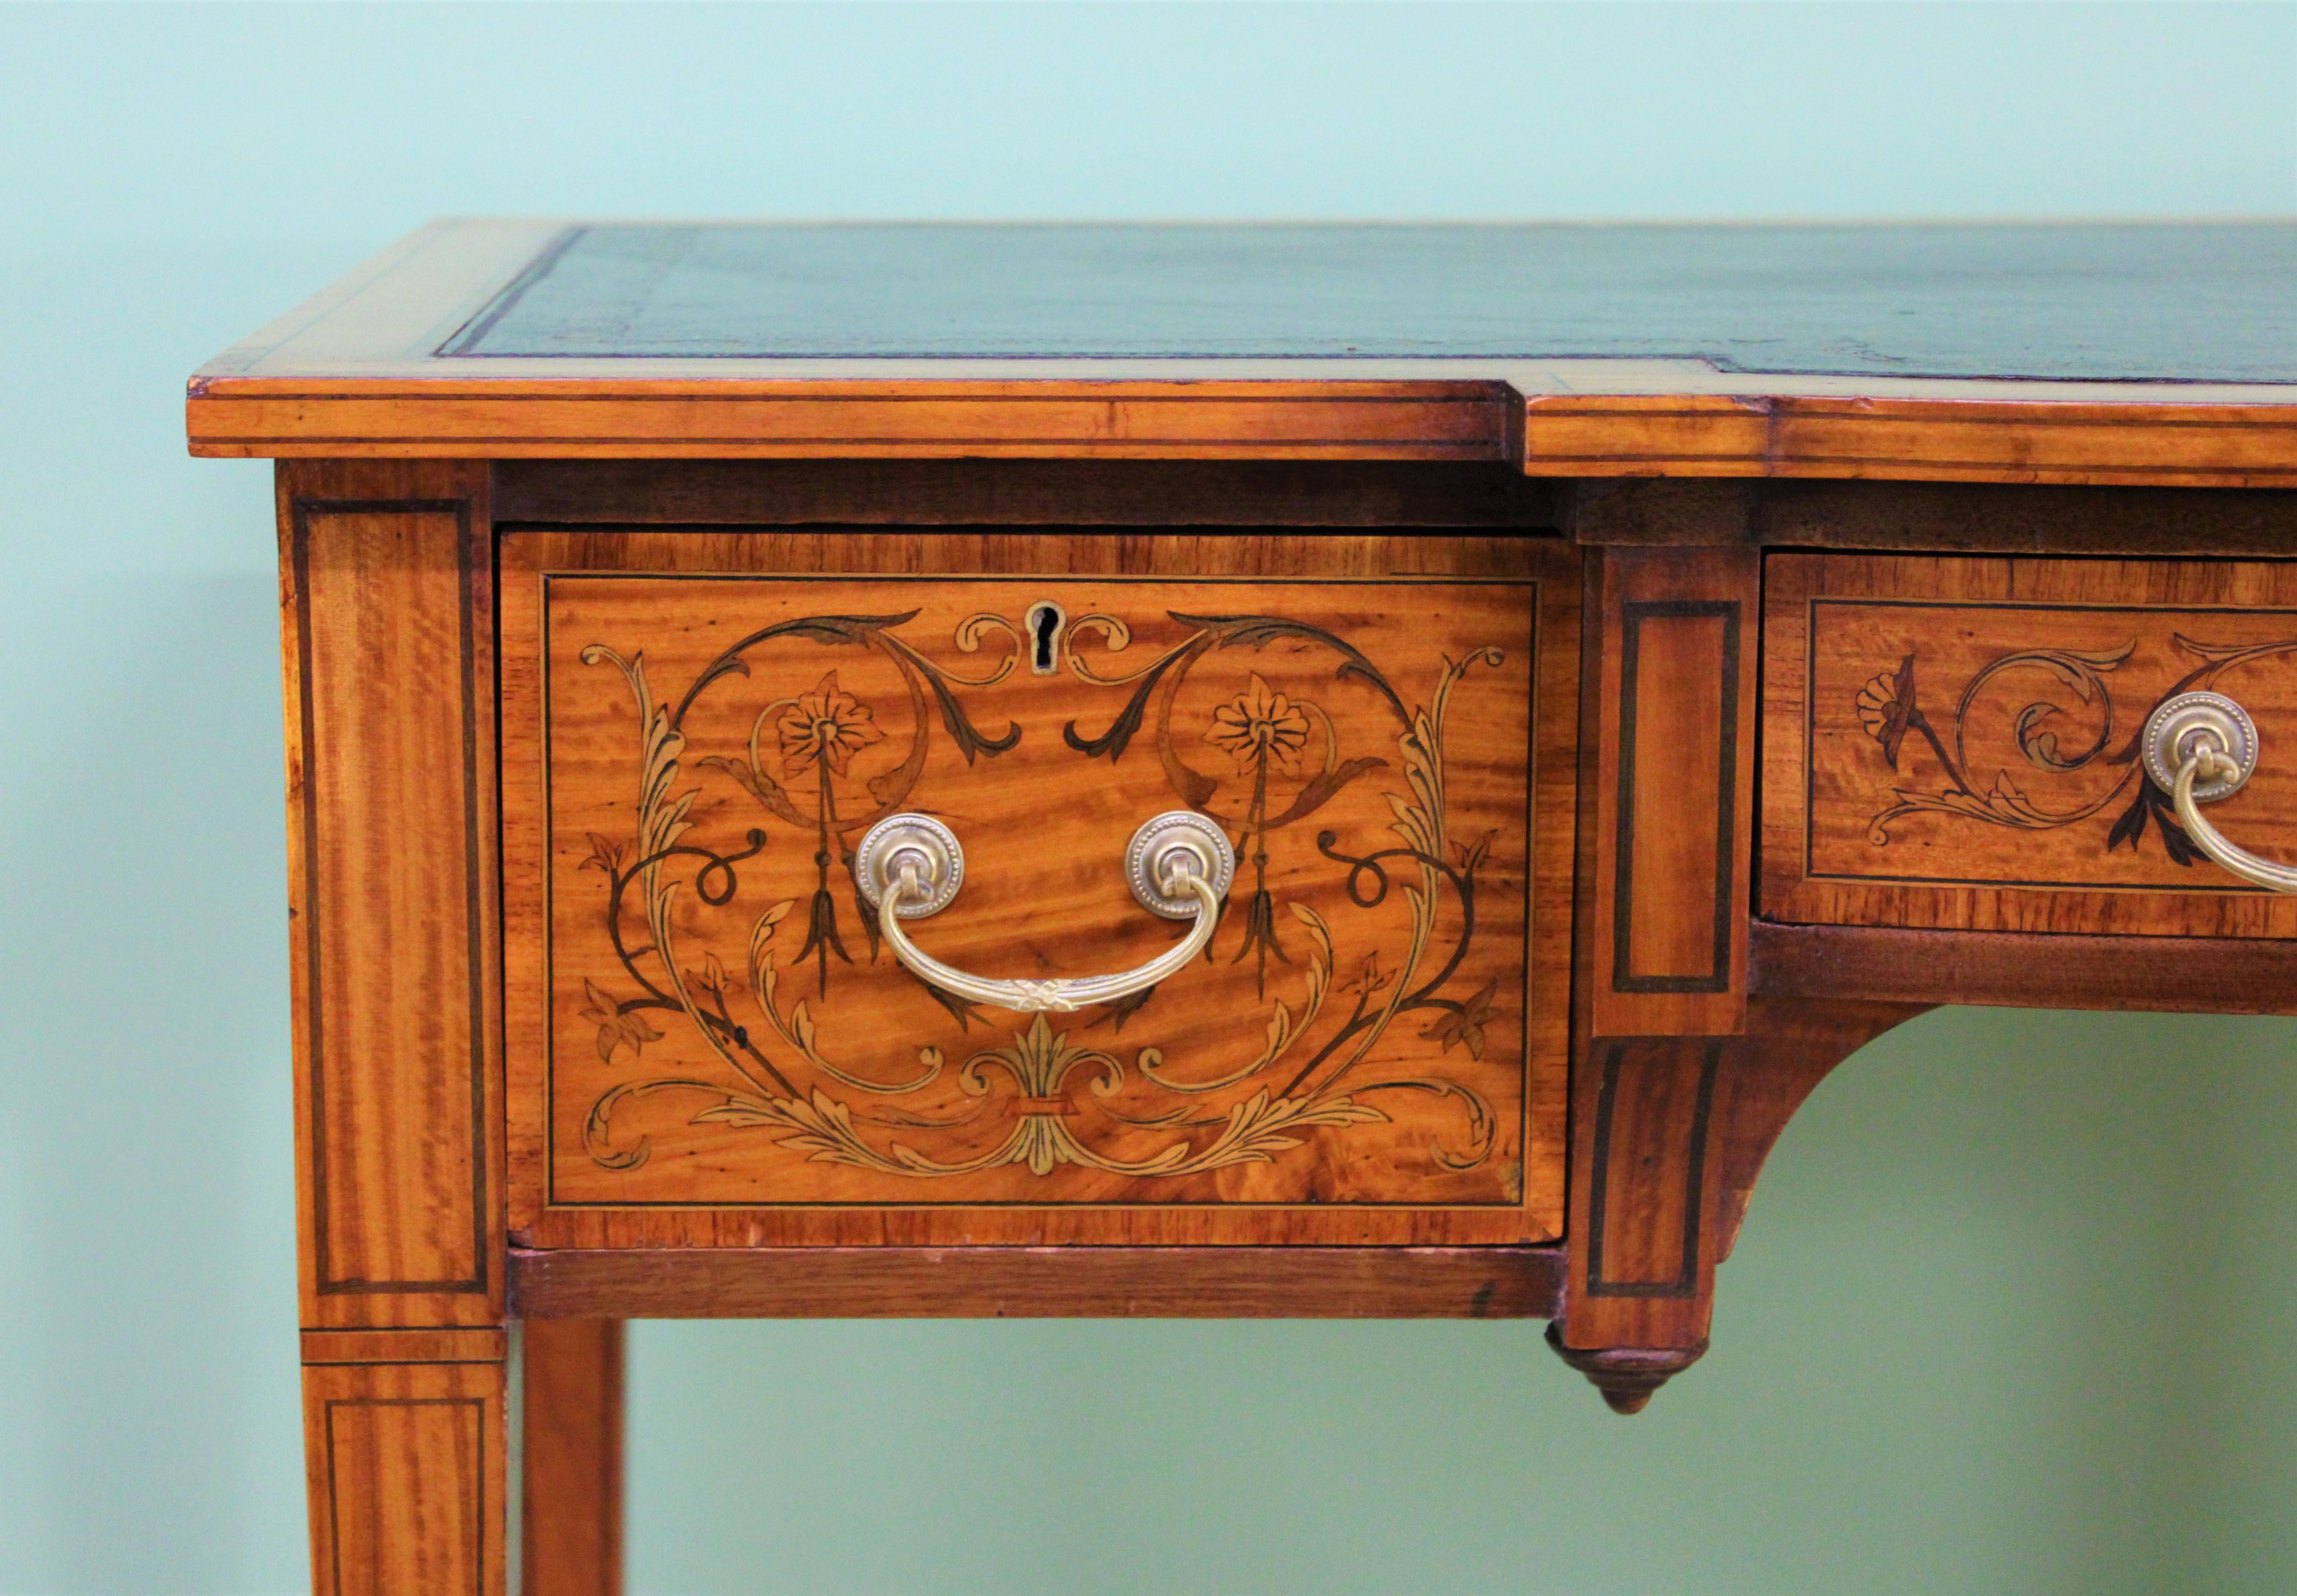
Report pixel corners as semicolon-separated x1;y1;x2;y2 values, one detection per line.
565;611;1505;1178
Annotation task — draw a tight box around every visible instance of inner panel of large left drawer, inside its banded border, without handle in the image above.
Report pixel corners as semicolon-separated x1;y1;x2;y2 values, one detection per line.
547;579;1530;1203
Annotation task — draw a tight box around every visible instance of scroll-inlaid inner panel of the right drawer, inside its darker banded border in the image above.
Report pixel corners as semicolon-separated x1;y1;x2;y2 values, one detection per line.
1808;599;2297;891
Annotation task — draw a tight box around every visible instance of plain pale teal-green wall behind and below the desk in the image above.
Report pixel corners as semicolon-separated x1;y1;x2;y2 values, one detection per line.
0;2;2297;1596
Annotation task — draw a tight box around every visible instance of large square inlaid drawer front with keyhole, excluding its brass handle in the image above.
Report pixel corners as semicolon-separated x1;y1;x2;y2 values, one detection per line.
501;530;1578;1245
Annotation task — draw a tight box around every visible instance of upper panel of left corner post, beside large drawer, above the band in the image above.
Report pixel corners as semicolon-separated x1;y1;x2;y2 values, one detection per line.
278;462;501;1327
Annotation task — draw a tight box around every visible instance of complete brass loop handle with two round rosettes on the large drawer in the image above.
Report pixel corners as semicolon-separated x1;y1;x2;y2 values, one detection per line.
855;811;1236;1015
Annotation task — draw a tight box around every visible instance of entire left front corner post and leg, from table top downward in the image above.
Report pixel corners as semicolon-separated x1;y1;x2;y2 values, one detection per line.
278;459;510;1596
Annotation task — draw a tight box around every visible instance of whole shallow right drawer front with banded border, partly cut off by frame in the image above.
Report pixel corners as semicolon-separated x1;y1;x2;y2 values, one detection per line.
1762;556;2297;937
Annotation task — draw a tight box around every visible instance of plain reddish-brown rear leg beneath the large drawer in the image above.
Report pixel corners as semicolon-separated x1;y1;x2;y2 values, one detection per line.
519;1318;623;1596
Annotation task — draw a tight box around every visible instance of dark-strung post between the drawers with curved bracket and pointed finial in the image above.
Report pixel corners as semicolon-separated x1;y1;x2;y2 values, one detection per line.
1548;544;1916;1412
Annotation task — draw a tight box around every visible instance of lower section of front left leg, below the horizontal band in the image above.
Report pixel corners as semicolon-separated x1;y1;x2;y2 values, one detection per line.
303;1364;505;1596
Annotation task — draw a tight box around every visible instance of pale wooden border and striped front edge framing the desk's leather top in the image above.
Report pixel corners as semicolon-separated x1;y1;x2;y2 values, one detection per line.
186;218;2297;487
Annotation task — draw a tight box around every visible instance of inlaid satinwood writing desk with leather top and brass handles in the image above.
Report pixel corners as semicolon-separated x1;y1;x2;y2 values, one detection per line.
188;223;2297;1596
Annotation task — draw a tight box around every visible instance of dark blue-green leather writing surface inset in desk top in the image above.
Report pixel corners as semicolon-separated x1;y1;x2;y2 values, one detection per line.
441;223;2297;381
